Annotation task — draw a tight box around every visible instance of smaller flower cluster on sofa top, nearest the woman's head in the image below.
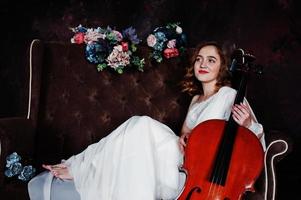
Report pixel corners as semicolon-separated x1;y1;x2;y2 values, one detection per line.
147;23;187;63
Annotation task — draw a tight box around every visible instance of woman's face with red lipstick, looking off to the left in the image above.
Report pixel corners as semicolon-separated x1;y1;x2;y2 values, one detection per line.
194;45;221;83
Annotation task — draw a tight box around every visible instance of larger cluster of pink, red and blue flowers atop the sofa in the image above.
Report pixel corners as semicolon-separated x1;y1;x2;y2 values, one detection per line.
71;25;145;74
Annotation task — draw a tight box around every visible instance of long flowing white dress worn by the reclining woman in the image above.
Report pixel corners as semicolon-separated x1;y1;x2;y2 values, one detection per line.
28;87;265;200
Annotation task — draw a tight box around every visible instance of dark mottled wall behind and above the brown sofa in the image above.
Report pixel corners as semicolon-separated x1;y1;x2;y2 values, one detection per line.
0;0;301;200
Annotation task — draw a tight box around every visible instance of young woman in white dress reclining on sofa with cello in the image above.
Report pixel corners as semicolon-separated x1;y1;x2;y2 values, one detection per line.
28;42;265;200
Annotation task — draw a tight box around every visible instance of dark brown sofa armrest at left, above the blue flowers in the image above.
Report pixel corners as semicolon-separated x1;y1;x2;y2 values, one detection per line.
0;117;35;186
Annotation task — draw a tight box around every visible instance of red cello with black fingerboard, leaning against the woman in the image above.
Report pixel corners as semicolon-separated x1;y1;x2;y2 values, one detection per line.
178;49;264;200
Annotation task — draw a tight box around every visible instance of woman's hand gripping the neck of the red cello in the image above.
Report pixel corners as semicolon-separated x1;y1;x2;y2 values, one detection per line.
232;103;252;128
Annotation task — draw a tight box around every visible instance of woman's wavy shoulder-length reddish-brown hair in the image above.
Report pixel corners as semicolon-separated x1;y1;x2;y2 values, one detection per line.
181;41;231;96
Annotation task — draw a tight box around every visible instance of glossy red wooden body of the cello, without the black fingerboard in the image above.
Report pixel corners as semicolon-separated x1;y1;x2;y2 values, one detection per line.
178;120;263;200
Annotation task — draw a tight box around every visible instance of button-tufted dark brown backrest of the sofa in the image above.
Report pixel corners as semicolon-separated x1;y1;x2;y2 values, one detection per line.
31;41;190;163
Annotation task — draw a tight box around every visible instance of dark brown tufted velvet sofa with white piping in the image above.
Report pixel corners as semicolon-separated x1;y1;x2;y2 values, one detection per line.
0;40;287;200
